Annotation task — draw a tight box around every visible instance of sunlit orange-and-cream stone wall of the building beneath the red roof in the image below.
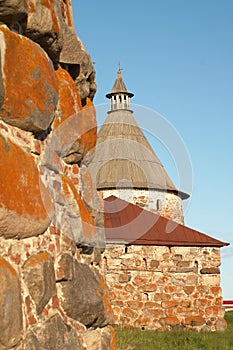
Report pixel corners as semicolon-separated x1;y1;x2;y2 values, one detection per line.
102;245;226;331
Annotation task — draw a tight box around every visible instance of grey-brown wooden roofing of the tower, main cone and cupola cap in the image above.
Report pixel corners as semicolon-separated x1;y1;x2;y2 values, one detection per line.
89;71;189;199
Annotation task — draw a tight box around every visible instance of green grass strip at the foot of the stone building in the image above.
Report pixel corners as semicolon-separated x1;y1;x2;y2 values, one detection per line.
116;311;233;350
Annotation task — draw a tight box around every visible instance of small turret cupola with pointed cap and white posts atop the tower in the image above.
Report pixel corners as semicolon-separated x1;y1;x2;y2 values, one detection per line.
106;67;134;111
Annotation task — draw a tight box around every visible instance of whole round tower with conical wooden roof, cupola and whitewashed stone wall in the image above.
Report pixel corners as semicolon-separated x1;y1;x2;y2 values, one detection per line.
90;69;188;224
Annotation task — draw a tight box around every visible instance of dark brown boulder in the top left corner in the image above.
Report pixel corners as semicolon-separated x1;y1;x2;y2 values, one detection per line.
0;0;27;23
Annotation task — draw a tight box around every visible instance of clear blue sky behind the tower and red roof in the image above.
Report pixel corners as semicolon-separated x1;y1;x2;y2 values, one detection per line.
73;0;233;299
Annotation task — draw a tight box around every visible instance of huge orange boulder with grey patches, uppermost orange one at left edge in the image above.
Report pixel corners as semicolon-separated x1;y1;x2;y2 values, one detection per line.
0;25;58;133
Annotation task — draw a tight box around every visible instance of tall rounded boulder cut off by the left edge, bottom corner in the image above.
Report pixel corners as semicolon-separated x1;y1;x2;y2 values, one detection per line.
0;258;23;349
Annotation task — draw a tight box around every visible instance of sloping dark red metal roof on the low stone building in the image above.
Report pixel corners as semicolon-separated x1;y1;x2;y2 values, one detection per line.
104;196;229;247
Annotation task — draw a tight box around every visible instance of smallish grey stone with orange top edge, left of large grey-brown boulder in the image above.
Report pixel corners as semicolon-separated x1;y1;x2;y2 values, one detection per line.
23;252;56;314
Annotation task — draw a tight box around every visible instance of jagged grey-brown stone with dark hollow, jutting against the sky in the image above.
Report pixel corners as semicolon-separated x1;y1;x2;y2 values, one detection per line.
59;26;96;105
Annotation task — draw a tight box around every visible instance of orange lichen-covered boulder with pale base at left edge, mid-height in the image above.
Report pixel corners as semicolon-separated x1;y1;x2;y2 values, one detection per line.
0;136;52;239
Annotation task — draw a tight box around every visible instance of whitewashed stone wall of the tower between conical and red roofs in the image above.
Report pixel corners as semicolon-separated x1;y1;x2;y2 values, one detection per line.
100;189;184;225
